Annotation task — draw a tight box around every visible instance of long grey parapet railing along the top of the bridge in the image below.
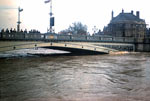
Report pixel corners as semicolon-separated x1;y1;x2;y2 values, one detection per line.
0;33;150;43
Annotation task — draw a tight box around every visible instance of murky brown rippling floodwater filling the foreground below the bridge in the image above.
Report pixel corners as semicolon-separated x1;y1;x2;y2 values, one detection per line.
0;53;150;101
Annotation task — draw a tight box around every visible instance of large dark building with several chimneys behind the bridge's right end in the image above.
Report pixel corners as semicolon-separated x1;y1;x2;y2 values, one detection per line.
103;10;146;37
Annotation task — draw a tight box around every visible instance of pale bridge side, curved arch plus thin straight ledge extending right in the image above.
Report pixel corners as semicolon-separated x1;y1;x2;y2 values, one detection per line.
0;41;133;53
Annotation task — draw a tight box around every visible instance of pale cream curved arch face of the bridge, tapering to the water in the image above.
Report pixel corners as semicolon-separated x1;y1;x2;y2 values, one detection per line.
0;41;124;53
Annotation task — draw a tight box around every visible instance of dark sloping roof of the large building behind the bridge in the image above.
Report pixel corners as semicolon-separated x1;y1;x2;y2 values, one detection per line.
110;12;145;24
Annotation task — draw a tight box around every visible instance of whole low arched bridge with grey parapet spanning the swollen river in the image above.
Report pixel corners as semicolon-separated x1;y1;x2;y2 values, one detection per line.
0;33;150;54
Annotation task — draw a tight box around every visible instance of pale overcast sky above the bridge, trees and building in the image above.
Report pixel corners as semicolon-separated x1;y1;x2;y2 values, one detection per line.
0;0;150;33
